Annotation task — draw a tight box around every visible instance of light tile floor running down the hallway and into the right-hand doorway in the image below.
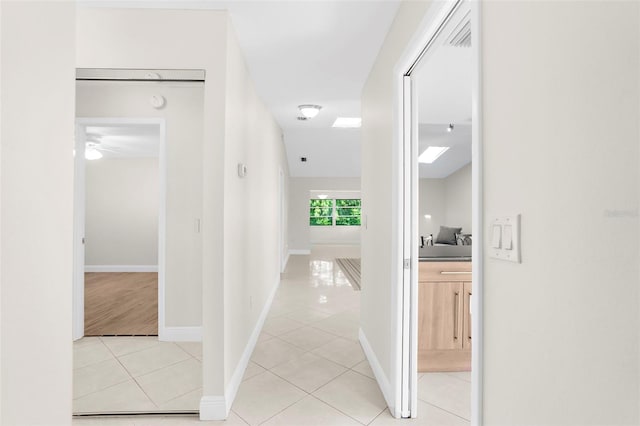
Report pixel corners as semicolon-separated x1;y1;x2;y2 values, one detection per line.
73;247;471;426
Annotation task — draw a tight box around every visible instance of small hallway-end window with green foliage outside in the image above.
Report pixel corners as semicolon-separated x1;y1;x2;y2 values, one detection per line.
309;198;362;226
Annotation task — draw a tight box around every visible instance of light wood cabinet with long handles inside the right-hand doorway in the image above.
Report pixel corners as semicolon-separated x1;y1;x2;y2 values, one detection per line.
418;261;471;372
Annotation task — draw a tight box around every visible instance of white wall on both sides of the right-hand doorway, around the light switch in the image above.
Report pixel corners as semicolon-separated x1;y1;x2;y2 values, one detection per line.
361;2;640;425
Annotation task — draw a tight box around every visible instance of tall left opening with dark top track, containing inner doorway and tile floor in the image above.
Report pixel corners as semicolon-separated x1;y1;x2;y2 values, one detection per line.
73;70;204;415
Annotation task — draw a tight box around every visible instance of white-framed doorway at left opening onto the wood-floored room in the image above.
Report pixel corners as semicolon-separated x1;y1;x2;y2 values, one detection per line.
74;118;166;338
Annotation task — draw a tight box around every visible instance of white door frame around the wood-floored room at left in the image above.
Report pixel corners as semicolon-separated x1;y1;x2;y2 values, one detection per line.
73;117;167;340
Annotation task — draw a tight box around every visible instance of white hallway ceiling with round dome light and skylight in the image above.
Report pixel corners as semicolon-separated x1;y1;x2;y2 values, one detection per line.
80;0;399;177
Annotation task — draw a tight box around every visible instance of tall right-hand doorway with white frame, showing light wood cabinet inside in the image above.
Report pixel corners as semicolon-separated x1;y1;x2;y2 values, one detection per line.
402;0;481;424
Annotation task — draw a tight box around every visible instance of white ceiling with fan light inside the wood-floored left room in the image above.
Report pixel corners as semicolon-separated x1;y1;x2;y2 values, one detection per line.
85;123;160;158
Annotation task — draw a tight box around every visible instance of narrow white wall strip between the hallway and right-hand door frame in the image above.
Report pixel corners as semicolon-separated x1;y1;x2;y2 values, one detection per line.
360;1;430;412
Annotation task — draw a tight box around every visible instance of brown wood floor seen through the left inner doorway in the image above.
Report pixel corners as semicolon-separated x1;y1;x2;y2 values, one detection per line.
84;272;158;336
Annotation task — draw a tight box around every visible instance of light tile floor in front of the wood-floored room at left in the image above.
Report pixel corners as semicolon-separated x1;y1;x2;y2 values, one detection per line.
73;337;202;414
